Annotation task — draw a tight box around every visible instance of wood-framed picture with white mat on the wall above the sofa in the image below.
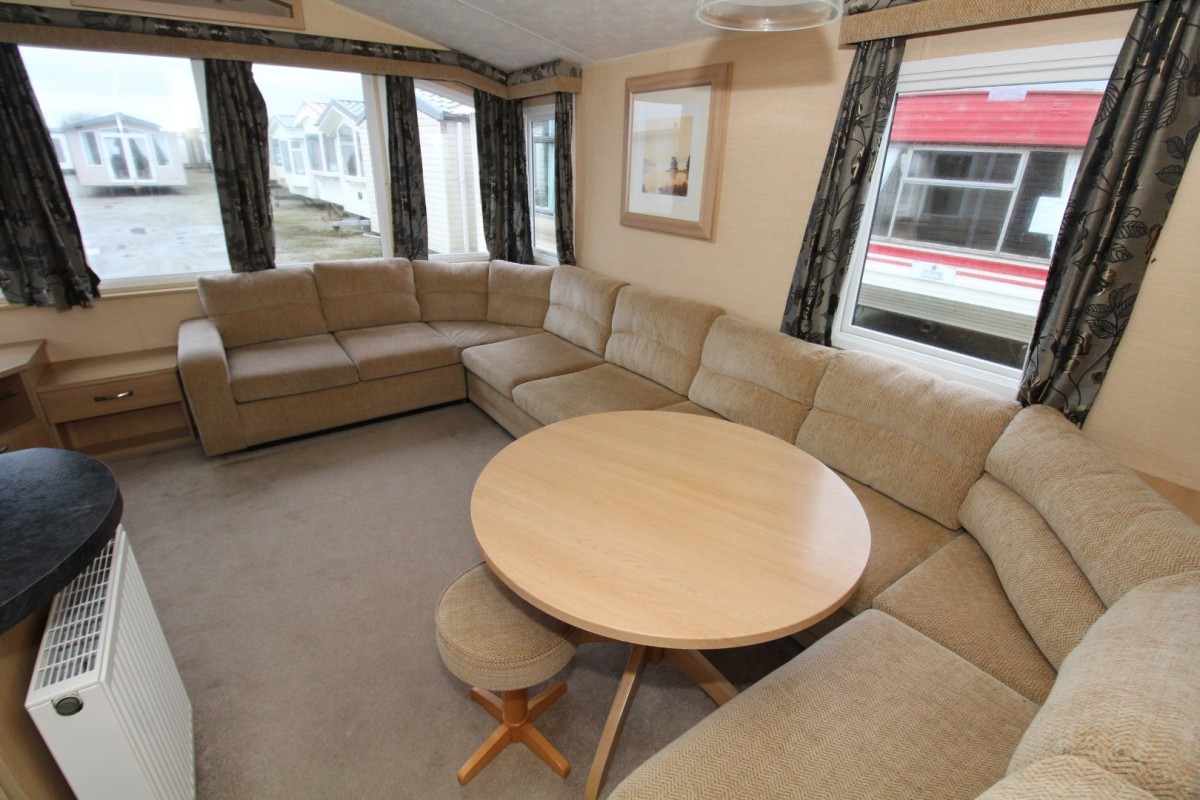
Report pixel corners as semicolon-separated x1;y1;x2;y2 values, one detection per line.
620;64;732;240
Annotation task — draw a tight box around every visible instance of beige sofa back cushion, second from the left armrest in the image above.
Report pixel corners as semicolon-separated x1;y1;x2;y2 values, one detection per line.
312;258;421;331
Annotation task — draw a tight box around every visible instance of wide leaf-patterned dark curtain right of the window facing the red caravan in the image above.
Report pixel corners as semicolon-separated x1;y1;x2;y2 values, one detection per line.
1020;0;1200;425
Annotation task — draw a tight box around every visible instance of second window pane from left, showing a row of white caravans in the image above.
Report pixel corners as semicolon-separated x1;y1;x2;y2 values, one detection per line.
254;64;390;266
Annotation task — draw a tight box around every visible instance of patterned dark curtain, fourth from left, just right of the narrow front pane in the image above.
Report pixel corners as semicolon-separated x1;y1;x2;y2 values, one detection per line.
475;89;533;264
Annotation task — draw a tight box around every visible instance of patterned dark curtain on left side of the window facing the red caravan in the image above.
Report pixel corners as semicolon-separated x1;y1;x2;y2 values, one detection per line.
780;34;904;344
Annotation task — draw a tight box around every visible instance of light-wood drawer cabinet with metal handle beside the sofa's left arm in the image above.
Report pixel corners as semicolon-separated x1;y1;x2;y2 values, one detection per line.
37;347;194;456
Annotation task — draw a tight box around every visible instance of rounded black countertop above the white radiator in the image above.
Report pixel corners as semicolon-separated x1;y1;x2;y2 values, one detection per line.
0;447;122;633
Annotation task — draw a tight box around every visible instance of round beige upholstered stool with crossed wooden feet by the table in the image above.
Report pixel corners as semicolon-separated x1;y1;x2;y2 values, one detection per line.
437;564;576;784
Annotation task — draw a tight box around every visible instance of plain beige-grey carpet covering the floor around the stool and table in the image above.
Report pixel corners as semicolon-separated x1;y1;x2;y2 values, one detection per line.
113;404;796;800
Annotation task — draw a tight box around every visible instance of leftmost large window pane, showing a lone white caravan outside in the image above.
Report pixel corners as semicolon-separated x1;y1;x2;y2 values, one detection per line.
20;46;229;287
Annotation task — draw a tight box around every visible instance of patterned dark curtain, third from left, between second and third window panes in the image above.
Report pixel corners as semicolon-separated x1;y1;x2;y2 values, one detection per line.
385;76;430;260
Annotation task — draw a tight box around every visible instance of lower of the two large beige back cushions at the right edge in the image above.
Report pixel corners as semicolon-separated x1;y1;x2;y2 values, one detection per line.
1008;572;1200;798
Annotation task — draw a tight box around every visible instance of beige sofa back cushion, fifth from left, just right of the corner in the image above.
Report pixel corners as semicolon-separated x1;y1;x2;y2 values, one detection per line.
542;266;628;356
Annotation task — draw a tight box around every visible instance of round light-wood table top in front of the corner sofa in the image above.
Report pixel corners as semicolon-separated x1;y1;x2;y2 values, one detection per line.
472;411;870;649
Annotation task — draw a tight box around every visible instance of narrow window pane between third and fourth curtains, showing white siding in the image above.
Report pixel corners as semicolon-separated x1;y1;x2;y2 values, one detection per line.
416;80;487;257
